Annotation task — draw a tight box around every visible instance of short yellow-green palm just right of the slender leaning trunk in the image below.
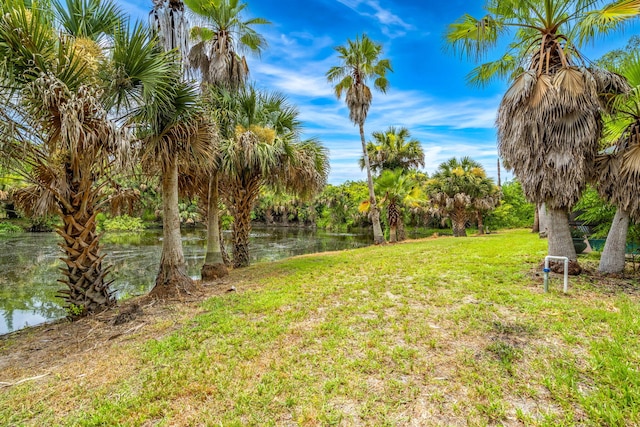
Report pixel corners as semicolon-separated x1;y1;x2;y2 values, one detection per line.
375;168;421;243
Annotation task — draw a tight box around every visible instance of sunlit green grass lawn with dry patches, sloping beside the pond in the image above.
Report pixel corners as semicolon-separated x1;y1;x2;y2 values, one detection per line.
0;231;640;426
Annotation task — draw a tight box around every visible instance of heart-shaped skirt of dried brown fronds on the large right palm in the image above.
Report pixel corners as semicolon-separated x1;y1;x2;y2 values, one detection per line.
497;67;602;207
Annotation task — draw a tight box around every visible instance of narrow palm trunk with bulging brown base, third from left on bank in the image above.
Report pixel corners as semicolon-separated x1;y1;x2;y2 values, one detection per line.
200;172;229;281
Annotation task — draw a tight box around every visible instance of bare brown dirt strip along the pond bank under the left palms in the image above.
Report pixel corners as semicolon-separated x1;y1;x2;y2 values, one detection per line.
0;273;252;388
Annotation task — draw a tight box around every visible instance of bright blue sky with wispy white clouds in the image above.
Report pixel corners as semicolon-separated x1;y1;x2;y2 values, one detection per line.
119;0;632;184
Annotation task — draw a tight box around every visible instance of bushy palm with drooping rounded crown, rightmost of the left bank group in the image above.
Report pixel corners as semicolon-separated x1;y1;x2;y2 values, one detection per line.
219;87;329;267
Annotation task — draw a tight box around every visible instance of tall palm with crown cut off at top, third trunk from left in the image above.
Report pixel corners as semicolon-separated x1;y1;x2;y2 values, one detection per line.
186;0;269;280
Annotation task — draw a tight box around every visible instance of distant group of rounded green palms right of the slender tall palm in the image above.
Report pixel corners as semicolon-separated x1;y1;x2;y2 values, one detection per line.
360;126;500;242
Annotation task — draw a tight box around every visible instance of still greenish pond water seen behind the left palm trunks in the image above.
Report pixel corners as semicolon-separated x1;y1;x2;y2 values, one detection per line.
0;227;373;335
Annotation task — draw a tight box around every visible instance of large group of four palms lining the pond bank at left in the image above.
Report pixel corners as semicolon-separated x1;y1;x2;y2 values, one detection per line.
0;0;328;318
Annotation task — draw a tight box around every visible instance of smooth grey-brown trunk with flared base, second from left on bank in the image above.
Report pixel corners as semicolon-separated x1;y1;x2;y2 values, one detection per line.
150;161;194;298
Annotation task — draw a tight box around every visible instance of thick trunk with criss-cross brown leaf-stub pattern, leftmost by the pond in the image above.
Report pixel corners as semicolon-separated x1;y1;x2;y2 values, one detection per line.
56;197;116;319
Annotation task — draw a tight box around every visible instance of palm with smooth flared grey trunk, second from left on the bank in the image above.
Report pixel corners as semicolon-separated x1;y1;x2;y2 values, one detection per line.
150;0;222;295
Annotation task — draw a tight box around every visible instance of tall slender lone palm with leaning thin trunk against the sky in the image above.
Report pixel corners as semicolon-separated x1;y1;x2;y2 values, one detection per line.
326;34;392;244
